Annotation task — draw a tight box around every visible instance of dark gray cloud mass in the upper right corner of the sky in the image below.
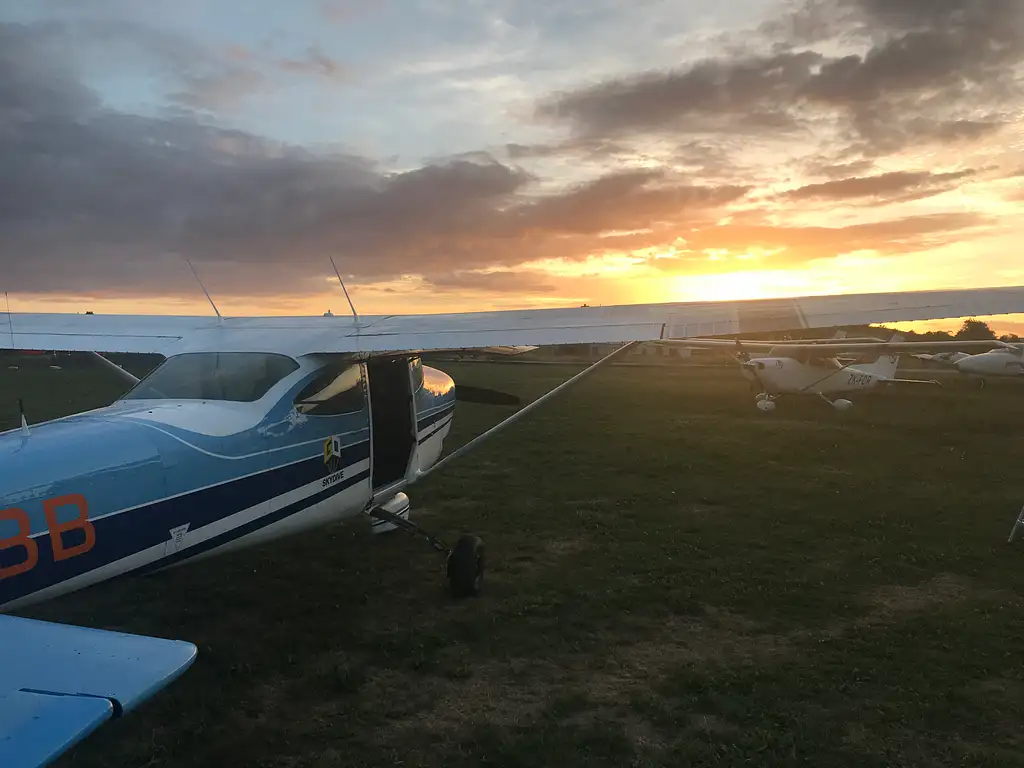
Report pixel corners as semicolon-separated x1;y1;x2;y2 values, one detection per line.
537;0;1024;156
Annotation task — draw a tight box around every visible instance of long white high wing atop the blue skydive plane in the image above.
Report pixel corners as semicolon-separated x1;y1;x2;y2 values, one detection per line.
0;286;1024;355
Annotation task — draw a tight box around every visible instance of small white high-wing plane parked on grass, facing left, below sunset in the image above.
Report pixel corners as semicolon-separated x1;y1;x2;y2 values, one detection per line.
654;334;1004;413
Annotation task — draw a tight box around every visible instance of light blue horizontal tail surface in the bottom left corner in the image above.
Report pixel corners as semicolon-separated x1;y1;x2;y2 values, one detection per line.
0;615;197;768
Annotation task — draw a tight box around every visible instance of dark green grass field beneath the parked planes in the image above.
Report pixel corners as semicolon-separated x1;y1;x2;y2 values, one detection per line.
0;364;1024;768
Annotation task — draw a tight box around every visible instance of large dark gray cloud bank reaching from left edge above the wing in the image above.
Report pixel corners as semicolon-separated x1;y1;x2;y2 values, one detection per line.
0;20;748;294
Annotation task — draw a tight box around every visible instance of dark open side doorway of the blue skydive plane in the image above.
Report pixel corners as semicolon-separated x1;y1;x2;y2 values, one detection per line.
367;357;416;490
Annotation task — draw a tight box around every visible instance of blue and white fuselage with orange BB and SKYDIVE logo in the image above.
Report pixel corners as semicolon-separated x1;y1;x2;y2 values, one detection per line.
0;352;455;609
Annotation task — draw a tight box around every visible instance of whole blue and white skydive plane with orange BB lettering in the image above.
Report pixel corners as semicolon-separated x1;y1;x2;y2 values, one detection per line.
6;284;1024;768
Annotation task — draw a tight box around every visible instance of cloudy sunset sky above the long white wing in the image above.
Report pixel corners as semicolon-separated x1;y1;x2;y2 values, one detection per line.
0;0;1024;331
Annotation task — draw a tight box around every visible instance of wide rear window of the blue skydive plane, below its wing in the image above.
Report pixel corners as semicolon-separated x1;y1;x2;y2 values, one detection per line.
124;352;299;402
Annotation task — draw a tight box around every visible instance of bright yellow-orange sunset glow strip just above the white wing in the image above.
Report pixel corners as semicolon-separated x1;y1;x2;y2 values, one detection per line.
6;231;1024;333
